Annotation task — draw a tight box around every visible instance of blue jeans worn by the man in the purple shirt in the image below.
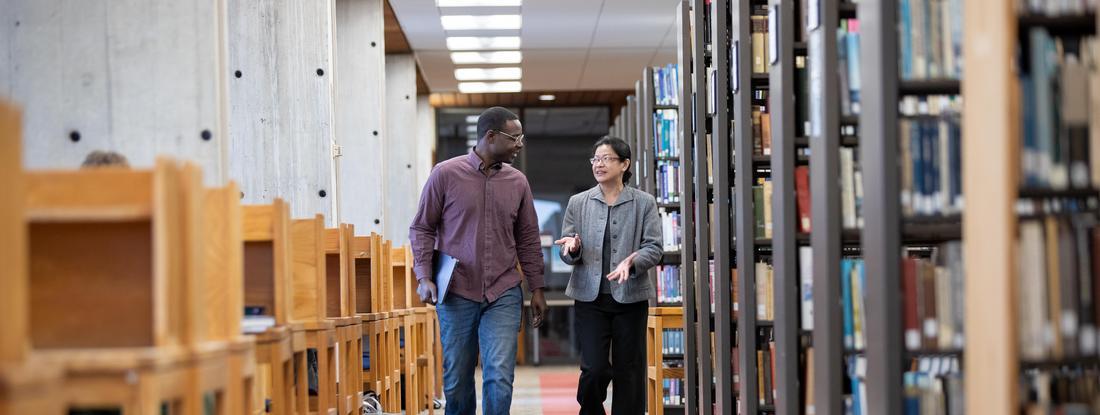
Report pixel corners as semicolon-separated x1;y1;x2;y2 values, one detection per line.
436;285;524;415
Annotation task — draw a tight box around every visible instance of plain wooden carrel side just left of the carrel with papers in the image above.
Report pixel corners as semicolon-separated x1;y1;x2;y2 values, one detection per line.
201;183;263;414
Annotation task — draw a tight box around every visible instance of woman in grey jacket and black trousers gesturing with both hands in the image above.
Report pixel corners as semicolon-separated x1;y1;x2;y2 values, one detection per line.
554;136;661;415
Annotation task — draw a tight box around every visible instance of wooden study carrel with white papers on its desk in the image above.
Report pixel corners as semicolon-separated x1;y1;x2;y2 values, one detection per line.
244;199;305;415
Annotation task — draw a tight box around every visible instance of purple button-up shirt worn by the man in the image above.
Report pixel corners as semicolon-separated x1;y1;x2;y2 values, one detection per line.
409;151;546;303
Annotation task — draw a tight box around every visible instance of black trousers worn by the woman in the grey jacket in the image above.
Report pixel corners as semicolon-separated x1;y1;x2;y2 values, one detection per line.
574;294;649;415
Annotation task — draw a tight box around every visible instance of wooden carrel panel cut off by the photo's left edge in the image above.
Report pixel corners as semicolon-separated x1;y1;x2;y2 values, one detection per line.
0;102;64;415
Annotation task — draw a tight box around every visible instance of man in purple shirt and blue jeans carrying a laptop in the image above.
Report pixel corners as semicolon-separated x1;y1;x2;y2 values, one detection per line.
409;107;547;415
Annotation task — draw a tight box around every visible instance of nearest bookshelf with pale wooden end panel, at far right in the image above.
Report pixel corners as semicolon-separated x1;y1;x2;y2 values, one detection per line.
963;1;1100;413
